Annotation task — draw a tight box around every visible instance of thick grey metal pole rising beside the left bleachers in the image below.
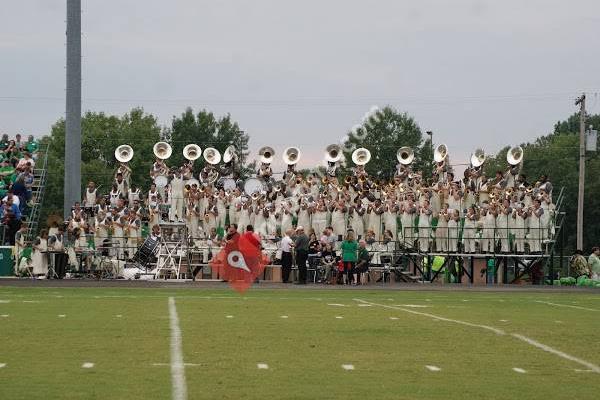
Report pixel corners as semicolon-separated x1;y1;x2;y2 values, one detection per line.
63;0;81;219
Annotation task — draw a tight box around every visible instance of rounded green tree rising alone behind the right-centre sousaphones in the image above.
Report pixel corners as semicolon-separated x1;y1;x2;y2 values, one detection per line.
344;106;431;179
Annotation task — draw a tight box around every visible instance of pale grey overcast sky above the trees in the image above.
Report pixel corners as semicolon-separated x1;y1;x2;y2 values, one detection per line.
0;0;600;170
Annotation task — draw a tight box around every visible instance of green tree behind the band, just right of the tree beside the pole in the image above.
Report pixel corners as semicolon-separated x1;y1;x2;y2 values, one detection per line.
164;108;249;172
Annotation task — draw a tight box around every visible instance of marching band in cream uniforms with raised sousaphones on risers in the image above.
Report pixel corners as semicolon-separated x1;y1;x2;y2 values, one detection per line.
63;142;554;258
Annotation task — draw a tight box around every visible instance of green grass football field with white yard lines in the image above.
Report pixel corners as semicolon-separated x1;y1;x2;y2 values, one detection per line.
0;288;600;400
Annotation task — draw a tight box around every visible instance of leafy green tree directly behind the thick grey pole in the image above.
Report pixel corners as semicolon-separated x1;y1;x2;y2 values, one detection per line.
41;108;161;225
